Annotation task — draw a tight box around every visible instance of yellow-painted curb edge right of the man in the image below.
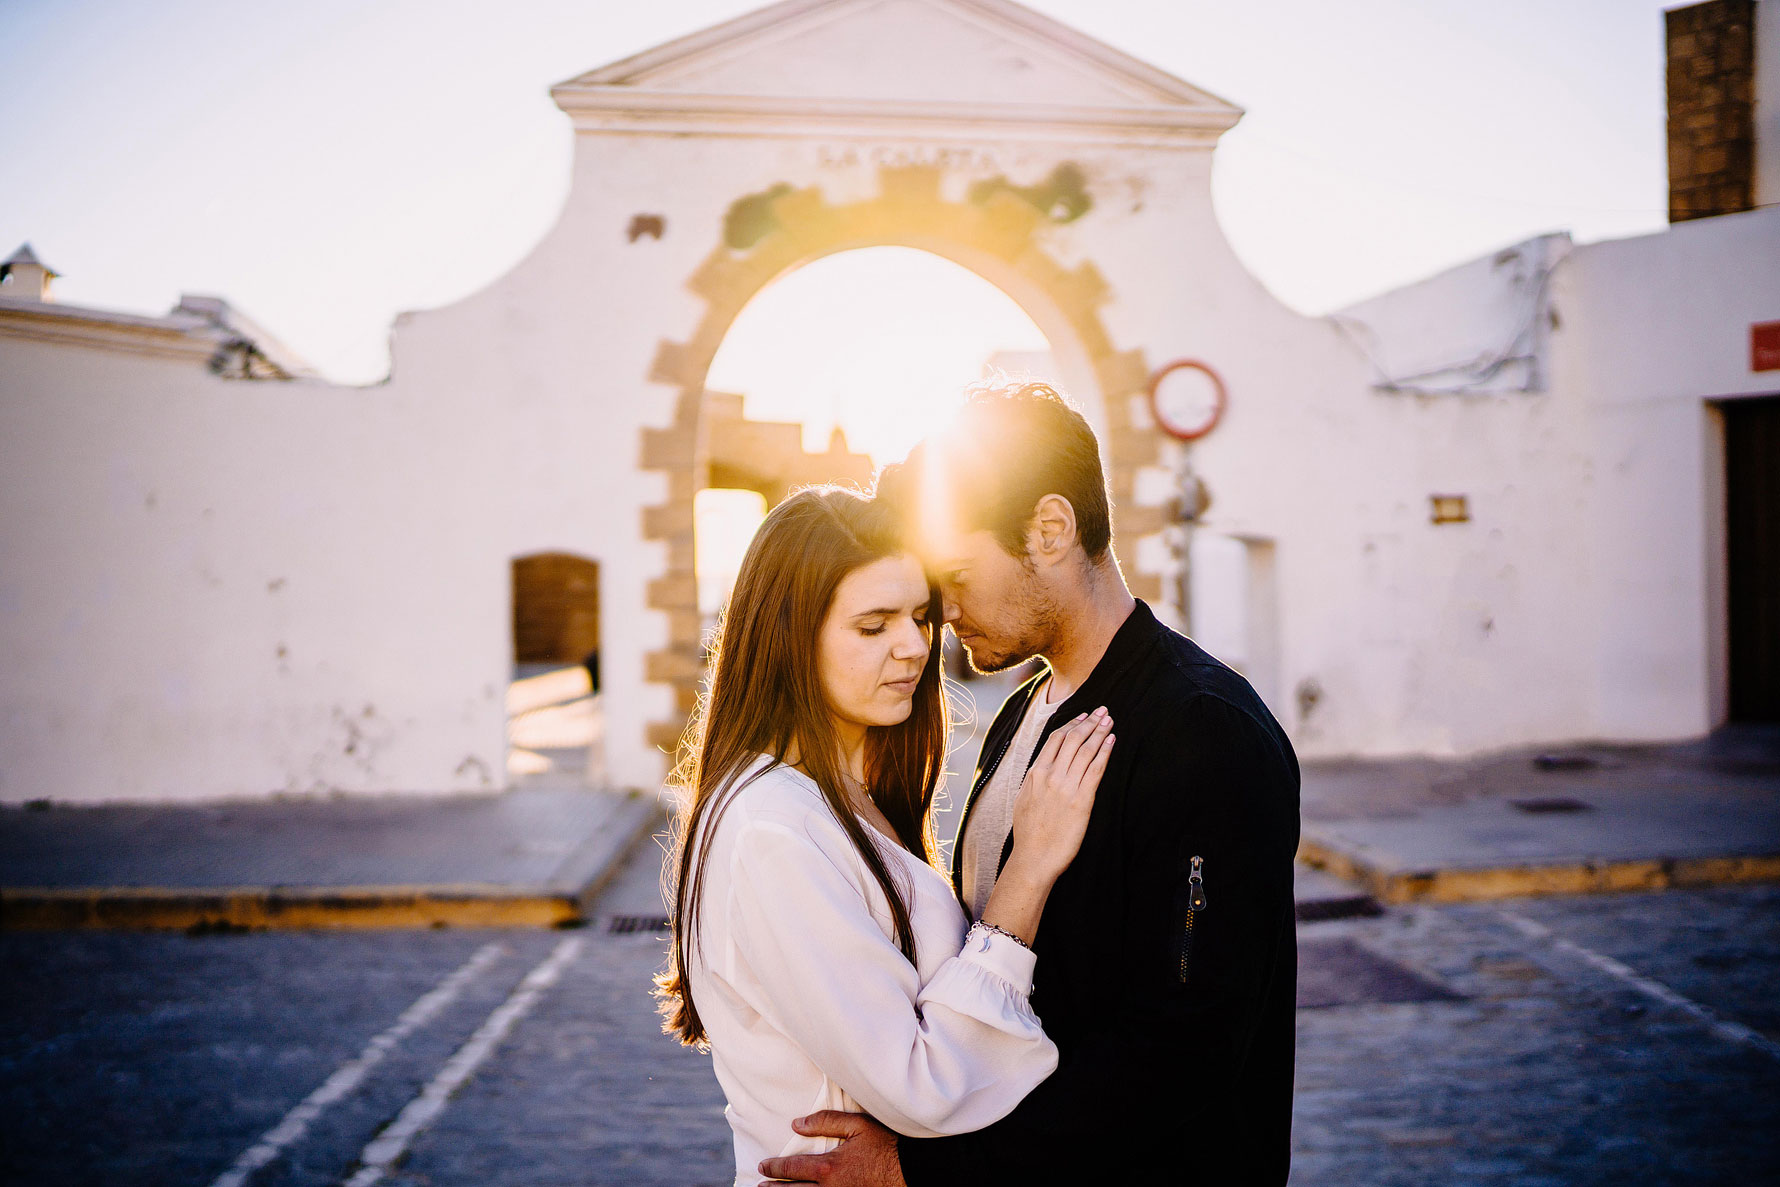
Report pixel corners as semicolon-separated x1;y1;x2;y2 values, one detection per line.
1298;836;1780;904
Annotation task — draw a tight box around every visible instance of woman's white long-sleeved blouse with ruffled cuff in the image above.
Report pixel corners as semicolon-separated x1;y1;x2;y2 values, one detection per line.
687;758;1057;1185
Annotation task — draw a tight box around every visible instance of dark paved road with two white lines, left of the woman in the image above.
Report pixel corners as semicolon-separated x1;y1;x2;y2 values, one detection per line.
0;847;728;1187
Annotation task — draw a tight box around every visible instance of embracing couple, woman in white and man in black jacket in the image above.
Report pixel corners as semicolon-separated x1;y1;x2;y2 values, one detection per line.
659;384;1298;1187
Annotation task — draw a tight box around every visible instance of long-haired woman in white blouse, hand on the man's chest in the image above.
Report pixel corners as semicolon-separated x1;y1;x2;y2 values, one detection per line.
659;489;1113;1183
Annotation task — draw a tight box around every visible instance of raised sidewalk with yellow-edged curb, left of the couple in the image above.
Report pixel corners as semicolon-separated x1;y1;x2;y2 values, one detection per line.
0;787;664;931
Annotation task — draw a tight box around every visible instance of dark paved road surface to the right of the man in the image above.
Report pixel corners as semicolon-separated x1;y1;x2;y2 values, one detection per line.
1292;886;1780;1187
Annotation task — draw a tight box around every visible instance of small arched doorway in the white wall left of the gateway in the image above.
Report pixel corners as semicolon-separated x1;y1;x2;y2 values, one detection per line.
507;552;605;785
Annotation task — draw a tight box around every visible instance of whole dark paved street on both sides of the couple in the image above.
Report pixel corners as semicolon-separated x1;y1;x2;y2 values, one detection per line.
0;839;1780;1187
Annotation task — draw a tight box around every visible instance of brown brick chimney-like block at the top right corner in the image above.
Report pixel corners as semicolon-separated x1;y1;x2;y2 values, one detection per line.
1663;0;1758;222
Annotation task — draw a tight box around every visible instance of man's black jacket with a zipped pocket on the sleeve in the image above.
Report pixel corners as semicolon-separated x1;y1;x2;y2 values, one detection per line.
899;602;1298;1187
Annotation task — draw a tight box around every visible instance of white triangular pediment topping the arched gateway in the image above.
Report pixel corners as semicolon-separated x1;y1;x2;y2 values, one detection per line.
557;0;1241;126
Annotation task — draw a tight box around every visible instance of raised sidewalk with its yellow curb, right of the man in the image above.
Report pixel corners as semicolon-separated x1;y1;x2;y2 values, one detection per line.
1298;726;1780;902
